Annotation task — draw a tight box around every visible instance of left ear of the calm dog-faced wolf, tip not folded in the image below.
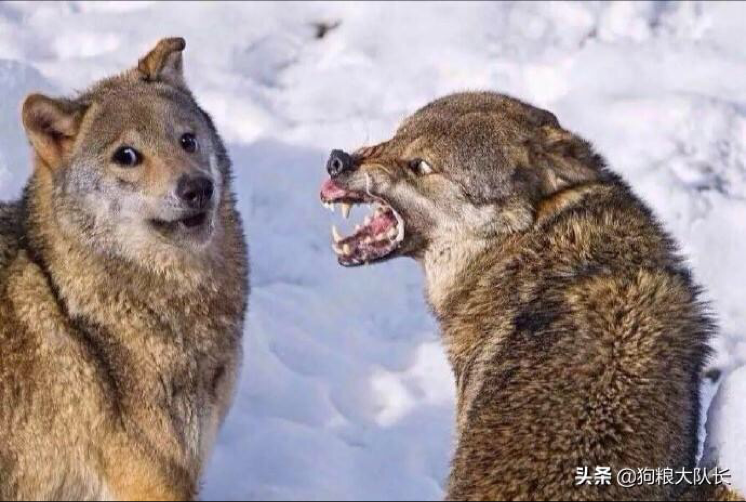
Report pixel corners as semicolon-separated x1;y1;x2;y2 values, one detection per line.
22;94;85;169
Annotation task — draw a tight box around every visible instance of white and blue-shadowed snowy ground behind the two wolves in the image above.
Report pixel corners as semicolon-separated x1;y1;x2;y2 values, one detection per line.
0;2;746;499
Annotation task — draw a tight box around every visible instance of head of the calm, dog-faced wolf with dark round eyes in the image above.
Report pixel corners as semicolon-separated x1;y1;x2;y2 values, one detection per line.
22;38;230;262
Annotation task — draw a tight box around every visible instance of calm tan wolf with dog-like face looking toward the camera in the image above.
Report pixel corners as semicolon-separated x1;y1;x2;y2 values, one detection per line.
0;39;248;500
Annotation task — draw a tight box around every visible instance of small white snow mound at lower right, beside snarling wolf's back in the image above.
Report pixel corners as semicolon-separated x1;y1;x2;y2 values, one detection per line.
704;367;746;493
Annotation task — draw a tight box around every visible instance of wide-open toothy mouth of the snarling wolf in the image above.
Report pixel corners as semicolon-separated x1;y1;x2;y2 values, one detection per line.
321;179;404;267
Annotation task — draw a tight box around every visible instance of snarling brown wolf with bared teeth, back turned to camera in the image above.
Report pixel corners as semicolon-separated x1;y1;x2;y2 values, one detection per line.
321;92;740;500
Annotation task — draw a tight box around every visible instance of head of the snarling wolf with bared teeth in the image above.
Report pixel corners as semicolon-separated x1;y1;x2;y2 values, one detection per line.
321;92;604;266
